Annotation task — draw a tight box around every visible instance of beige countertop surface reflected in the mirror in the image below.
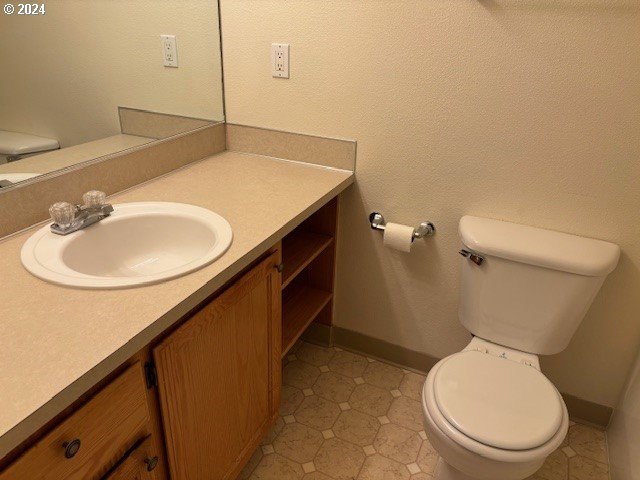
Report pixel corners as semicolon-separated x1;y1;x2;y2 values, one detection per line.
0;133;155;174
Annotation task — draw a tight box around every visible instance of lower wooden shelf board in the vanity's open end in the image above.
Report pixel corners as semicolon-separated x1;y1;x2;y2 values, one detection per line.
282;283;332;357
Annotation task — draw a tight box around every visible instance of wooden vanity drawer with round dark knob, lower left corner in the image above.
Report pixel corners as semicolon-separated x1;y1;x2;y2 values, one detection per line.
0;362;150;480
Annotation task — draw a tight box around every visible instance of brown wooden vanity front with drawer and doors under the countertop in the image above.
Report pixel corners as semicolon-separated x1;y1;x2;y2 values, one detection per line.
0;244;282;480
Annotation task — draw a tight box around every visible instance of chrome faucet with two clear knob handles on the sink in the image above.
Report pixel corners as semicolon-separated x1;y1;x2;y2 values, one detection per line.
49;190;113;235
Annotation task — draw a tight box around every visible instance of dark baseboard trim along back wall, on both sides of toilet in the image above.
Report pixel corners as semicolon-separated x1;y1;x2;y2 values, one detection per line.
322;324;613;428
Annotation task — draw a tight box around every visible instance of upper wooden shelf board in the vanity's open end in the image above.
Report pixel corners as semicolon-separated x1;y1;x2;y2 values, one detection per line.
282;229;333;288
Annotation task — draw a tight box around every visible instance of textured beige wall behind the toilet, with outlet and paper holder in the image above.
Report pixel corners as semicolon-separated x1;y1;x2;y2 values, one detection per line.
221;0;640;406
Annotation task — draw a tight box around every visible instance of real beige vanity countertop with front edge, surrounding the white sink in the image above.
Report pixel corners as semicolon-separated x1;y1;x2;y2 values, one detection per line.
0;152;354;458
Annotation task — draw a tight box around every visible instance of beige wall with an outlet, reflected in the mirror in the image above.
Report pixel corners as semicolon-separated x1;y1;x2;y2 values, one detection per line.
0;0;223;147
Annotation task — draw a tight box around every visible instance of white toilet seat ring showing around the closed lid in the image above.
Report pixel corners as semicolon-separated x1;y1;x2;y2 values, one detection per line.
422;350;569;464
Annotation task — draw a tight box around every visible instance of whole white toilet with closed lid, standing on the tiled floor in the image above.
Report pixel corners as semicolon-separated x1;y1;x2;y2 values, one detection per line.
422;216;620;480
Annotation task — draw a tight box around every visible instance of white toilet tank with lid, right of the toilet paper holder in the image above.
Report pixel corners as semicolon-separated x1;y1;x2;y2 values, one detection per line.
458;216;620;355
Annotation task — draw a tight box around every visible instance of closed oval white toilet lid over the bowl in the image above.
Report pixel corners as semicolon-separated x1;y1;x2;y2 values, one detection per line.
434;351;564;450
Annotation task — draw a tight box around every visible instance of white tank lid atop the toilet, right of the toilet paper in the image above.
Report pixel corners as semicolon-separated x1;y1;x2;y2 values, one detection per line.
458;215;620;277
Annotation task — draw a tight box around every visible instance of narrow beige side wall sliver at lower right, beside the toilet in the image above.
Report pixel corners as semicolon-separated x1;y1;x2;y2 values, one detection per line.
607;348;640;480
